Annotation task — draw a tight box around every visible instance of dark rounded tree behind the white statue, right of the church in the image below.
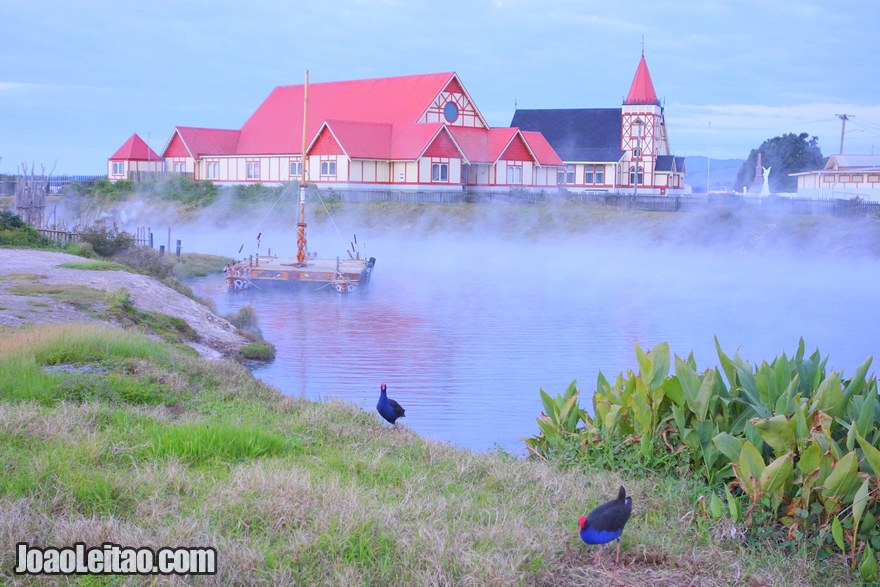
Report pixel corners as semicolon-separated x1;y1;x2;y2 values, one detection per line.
736;132;826;193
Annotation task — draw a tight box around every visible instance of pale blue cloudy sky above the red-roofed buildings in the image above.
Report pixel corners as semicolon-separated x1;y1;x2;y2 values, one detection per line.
0;0;880;175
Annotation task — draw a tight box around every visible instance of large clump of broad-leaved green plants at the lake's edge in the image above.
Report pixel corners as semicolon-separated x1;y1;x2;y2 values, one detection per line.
527;339;880;581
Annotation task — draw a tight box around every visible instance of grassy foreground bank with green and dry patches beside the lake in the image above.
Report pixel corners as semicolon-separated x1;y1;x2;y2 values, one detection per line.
0;325;847;585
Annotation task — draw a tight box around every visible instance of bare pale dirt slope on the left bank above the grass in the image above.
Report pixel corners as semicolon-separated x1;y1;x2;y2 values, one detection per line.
0;249;249;359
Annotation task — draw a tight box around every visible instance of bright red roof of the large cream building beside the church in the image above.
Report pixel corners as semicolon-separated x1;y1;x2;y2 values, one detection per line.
141;72;562;165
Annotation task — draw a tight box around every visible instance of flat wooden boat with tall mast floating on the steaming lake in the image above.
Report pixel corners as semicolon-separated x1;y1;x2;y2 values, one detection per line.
226;70;376;293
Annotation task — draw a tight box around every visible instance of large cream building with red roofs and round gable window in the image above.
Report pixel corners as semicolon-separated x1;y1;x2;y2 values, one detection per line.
111;73;563;189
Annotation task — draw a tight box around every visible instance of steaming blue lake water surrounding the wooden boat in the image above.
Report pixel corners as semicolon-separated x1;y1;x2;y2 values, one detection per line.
82;191;880;453
